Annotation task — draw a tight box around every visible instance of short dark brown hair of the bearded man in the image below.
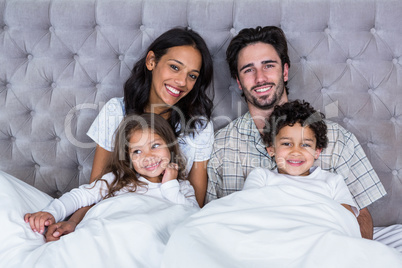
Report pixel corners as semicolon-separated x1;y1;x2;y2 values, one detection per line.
226;26;290;94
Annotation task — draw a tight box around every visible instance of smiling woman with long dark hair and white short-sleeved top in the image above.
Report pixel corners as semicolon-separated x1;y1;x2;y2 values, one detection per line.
46;28;213;241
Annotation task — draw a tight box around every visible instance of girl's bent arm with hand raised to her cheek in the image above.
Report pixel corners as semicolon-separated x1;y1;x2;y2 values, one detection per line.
161;163;199;208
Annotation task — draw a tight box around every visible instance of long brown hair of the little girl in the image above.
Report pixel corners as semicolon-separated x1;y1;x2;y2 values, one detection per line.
97;113;186;198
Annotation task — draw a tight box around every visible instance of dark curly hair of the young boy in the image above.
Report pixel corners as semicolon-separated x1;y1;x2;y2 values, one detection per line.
262;100;328;149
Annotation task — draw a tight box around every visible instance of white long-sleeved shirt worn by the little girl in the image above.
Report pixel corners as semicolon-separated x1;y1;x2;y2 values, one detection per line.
43;173;199;222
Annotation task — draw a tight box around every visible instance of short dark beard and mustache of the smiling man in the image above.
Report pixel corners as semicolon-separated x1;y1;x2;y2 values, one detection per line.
242;75;285;110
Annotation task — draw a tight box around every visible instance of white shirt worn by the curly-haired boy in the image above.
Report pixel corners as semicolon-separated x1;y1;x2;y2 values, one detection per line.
243;167;359;217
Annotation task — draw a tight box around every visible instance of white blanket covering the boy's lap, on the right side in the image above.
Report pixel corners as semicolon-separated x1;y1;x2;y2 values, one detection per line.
162;186;402;268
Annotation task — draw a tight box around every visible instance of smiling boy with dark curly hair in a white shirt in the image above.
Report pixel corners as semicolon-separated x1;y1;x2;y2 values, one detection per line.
243;101;359;217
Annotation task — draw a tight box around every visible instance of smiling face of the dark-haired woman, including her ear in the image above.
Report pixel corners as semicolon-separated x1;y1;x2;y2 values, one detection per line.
145;46;202;114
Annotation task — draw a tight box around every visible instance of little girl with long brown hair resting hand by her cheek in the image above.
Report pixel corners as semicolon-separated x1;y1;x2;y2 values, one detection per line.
24;114;199;234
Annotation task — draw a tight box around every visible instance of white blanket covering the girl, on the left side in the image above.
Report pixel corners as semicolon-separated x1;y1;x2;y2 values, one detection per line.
0;172;198;268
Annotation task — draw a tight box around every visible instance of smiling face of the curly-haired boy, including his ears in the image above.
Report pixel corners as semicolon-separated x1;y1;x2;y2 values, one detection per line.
267;123;321;176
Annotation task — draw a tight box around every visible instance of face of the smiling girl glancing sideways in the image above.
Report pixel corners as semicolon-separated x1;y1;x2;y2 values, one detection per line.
129;129;171;182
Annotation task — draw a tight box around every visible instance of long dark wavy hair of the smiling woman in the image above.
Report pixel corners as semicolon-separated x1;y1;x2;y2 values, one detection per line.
124;28;213;136
